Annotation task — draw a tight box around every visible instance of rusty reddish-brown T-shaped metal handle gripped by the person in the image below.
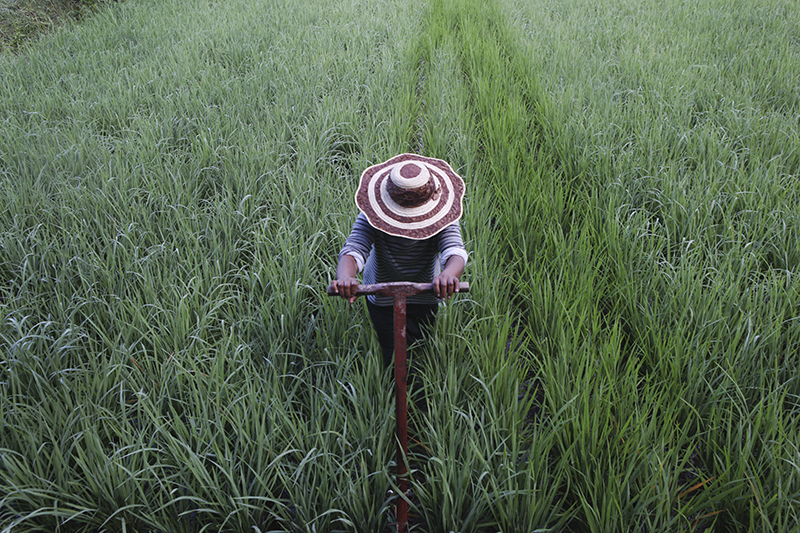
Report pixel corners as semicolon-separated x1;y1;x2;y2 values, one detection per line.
328;281;469;533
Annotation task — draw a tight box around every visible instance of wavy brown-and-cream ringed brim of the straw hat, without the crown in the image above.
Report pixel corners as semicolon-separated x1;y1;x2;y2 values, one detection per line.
355;154;464;240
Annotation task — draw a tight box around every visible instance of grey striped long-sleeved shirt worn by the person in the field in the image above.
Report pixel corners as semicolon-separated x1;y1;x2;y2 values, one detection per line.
339;213;467;305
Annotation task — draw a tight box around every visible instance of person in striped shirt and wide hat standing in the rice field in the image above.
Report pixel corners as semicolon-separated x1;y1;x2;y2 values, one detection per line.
332;154;467;367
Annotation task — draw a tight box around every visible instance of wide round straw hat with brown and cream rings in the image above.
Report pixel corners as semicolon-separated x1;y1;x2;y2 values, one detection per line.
356;154;464;240
